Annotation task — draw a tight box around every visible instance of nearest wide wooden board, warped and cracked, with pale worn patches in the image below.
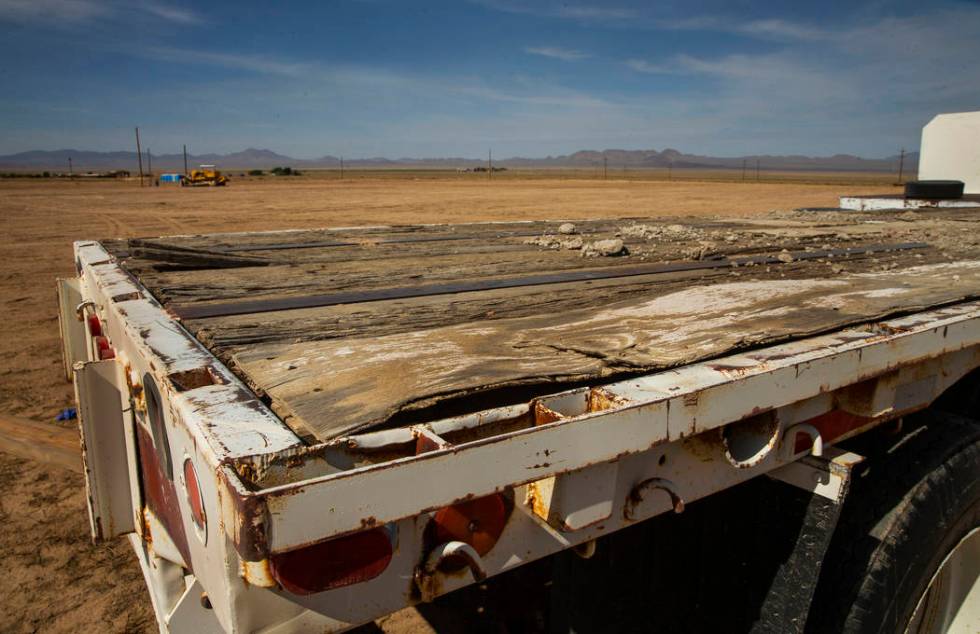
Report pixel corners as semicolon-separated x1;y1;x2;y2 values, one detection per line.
231;261;980;440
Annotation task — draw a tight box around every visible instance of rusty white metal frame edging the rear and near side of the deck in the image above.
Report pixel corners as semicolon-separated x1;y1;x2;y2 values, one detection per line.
75;237;980;631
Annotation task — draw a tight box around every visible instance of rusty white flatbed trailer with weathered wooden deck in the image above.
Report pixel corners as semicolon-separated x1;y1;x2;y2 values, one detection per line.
59;209;980;632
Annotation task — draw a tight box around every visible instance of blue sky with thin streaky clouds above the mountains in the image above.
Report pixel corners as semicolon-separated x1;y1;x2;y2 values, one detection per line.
0;0;980;158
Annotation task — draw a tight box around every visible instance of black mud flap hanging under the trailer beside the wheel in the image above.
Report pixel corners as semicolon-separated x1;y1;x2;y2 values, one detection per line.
548;449;861;634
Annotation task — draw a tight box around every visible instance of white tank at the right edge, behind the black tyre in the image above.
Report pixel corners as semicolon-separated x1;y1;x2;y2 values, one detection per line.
919;112;980;194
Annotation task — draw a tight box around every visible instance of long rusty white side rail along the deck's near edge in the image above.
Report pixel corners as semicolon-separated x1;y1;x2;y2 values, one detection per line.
232;303;980;552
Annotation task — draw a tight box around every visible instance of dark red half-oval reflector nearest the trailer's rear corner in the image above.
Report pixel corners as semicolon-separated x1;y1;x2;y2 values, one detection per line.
269;528;392;594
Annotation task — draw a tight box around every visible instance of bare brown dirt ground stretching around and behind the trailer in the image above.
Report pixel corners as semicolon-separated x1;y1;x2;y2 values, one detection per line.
0;173;896;632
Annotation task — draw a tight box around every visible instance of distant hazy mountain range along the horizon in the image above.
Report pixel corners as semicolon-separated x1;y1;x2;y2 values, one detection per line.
0;148;919;173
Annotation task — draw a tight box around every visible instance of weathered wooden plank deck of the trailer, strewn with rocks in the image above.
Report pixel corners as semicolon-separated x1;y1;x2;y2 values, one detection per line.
103;210;980;441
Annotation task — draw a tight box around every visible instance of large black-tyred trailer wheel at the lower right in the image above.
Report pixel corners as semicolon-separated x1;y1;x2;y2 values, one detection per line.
806;409;980;634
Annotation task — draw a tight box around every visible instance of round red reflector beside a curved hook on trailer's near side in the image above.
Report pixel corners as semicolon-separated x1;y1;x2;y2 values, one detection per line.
432;493;507;555
